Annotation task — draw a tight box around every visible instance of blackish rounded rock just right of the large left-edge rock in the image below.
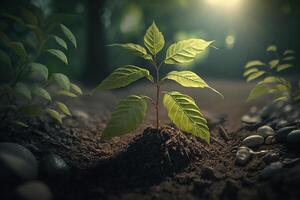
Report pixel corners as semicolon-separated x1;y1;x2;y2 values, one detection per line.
40;154;70;181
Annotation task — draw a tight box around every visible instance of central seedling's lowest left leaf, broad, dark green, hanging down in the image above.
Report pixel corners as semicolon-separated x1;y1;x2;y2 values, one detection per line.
102;95;148;139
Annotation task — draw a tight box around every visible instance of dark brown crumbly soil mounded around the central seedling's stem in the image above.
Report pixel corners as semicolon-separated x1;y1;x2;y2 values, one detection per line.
0;80;300;200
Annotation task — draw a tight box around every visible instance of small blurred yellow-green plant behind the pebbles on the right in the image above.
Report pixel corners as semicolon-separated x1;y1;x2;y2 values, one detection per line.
244;45;300;102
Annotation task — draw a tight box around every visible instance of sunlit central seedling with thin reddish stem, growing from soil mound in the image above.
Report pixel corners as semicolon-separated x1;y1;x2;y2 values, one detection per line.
96;22;221;143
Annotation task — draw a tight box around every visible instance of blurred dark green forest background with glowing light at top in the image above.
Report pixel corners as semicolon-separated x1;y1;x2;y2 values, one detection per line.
0;0;300;86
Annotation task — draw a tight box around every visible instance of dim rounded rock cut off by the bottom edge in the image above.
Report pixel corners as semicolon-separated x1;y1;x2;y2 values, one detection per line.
13;181;52;200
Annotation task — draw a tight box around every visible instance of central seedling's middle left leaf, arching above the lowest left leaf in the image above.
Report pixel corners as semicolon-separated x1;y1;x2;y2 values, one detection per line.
96;65;153;90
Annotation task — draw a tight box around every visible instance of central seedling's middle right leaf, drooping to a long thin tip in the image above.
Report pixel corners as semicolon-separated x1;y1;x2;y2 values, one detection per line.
163;71;223;97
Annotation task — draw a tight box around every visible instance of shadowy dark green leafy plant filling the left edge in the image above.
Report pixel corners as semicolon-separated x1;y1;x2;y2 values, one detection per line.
0;6;82;127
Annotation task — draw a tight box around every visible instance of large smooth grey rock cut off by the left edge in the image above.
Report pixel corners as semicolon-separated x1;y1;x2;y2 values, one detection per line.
0;142;38;185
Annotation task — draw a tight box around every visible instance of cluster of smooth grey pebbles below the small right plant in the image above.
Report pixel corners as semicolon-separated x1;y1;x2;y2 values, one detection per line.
236;102;300;174
